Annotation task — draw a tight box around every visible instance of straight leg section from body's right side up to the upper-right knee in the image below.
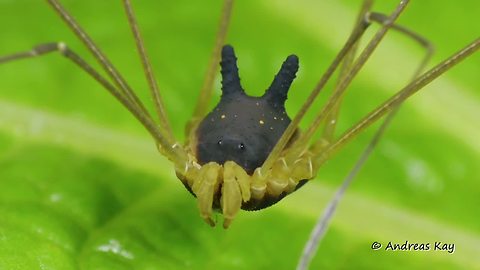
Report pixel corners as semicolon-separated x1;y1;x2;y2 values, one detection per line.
260;0;378;172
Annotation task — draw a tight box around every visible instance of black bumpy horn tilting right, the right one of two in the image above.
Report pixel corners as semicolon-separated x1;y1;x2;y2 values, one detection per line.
263;54;298;106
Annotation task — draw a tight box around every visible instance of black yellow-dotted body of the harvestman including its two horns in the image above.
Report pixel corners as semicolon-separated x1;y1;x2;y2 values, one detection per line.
192;45;298;210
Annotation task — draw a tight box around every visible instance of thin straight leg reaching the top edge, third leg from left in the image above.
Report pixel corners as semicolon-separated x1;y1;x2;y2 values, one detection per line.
123;0;174;141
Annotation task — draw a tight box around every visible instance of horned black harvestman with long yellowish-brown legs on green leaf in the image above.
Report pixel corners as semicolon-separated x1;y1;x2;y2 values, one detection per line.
0;0;480;230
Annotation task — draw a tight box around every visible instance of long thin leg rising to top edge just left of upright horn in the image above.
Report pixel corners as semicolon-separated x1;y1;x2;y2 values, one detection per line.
185;0;234;137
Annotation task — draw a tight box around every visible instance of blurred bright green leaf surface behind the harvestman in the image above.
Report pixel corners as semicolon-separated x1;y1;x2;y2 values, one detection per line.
0;0;480;269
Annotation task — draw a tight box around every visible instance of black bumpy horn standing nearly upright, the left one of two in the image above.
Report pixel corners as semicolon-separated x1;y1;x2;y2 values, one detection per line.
220;45;244;97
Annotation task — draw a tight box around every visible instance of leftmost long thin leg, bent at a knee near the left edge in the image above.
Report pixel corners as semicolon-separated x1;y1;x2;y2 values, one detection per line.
0;42;186;166
